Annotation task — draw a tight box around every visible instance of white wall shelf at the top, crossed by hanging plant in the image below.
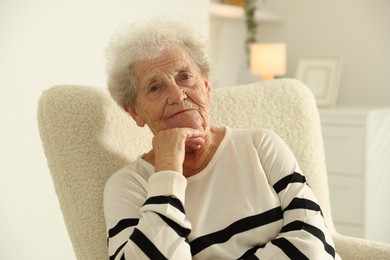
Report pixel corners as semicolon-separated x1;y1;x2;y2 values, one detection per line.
210;3;283;22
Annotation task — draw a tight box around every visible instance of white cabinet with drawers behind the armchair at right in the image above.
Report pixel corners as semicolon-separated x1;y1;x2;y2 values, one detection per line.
320;107;390;243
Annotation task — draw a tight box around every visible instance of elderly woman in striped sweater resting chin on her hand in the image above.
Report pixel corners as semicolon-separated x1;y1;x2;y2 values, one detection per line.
104;20;338;260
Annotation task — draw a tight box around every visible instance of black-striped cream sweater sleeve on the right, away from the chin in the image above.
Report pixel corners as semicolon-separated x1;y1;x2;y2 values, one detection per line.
253;130;339;259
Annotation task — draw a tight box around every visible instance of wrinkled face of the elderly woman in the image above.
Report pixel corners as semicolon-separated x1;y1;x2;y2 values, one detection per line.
125;45;210;134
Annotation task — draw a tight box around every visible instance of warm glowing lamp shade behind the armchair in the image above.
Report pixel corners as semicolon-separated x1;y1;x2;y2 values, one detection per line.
250;43;287;80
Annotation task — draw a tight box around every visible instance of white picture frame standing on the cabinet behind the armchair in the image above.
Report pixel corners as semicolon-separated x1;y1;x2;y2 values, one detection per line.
295;57;343;107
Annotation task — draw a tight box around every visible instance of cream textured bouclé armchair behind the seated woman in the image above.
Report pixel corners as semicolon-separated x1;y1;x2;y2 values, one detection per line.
38;79;390;260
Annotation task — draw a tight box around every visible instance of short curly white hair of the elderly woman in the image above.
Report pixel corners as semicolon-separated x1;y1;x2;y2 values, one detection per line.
106;19;210;107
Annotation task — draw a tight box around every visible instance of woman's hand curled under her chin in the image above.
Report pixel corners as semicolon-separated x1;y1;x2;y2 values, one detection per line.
153;128;205;173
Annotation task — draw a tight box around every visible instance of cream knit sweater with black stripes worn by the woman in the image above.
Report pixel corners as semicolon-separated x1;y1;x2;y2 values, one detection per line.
104;128;339;260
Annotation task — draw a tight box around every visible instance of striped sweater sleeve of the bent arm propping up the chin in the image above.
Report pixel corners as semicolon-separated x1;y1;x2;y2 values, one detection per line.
104;171;191;259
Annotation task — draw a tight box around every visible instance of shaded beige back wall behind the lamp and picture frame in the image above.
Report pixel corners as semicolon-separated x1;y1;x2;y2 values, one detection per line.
211;0;390;106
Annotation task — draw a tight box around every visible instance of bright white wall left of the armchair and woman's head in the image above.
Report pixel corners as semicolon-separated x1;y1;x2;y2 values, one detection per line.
0;0;208;260
